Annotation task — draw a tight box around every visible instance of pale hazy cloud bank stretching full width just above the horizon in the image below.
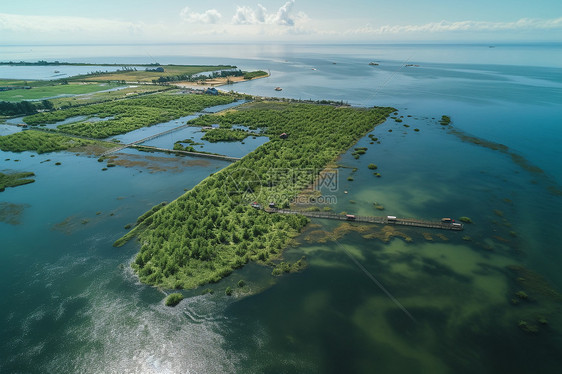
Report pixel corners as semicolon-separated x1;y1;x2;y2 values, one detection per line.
0;0;562;44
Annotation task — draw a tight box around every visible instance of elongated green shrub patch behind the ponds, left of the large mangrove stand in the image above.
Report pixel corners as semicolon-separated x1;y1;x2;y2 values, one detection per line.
24;94;235;138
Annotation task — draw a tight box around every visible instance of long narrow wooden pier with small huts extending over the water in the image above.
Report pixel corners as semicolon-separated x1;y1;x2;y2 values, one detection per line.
264;208;464;231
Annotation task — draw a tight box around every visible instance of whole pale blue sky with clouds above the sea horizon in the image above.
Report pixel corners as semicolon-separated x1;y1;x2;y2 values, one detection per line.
0;0;562;45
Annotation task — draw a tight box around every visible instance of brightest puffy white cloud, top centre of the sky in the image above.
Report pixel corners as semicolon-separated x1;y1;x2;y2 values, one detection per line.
232;0;298;26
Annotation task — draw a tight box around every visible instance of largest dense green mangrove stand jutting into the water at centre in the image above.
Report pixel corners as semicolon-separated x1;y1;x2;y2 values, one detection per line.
114;101;394;289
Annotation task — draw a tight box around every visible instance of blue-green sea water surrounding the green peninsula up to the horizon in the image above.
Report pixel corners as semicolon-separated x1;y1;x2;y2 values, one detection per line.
0;45;562;373
